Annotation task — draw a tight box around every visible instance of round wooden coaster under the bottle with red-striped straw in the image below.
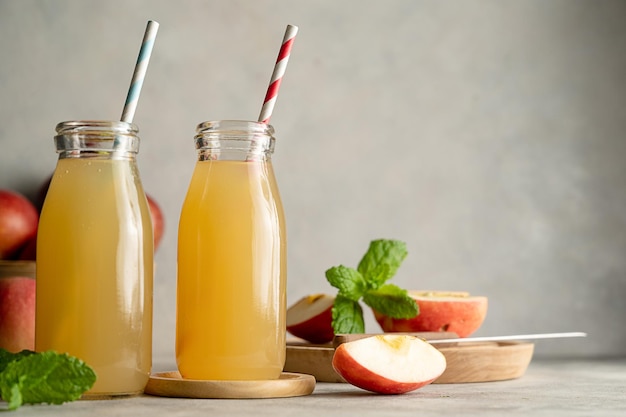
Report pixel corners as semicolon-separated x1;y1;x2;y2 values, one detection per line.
144;371;315;398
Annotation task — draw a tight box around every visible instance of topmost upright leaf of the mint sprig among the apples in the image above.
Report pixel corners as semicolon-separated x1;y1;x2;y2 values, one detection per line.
357;239;408;289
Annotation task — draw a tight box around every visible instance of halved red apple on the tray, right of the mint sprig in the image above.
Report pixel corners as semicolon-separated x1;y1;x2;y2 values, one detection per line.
374;291;487;337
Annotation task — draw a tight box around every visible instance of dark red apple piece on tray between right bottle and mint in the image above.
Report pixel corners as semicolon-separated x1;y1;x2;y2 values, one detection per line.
287;294;335;343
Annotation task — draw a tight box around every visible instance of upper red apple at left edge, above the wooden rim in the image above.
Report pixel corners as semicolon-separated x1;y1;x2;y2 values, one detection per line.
0;190;39;259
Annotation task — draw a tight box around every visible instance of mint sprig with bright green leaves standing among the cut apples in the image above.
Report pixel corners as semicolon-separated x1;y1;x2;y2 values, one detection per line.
326;239;419;334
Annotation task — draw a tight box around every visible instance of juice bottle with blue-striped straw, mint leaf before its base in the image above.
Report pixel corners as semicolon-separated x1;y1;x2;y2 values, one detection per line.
35;121;153;396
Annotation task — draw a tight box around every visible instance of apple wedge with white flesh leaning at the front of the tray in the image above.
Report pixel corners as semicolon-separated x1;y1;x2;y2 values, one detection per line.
333;334;446;394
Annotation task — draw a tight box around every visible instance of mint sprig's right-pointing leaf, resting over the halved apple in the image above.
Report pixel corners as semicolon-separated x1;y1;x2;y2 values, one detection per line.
363;284;419;319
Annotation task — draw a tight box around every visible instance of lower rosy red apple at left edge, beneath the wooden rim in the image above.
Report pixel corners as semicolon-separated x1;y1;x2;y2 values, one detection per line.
0;277;35;352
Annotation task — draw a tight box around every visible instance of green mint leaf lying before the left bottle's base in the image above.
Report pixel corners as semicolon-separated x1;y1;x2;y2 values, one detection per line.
0;351;96;410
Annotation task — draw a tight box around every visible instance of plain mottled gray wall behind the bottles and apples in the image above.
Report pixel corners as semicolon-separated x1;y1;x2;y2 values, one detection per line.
0;0;626;361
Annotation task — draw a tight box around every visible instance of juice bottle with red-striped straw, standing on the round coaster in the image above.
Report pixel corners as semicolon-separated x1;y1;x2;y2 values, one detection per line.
176;121;286;380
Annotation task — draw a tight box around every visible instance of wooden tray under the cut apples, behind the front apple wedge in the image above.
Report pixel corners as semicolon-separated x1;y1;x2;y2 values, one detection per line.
284;334;534;384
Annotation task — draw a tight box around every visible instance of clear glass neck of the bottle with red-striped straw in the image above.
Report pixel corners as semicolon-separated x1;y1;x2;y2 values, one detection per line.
195;120;275;161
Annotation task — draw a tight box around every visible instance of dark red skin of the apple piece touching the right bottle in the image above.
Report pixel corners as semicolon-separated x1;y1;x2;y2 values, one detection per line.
287;294;335;344
